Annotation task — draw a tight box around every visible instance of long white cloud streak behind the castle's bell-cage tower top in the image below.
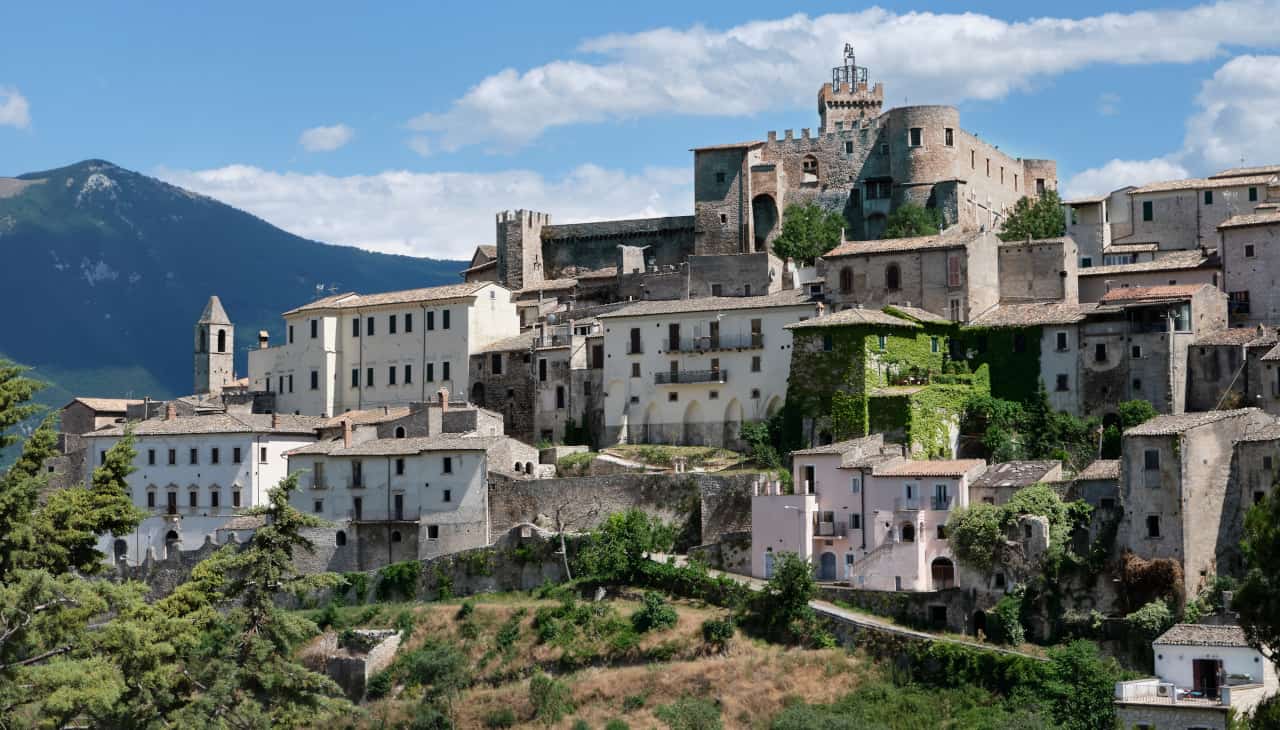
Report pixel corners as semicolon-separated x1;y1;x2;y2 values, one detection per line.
408;0;1280;150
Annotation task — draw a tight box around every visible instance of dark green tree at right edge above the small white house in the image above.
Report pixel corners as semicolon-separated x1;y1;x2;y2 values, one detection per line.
1233;487;1280;665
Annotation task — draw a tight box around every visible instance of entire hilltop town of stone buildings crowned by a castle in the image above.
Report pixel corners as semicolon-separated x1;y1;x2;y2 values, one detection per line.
15;49;1280;729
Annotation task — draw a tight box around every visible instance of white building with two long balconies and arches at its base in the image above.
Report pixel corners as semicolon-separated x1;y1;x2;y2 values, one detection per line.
599;289;814;448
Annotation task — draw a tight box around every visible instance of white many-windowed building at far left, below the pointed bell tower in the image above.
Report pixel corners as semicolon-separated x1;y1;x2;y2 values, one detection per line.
83;405;320;565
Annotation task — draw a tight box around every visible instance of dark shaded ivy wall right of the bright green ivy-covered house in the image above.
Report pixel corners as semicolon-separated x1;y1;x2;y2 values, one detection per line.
956;327;1041;403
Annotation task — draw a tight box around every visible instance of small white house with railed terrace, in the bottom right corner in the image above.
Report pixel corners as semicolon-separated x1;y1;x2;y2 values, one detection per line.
1115;624;1280;730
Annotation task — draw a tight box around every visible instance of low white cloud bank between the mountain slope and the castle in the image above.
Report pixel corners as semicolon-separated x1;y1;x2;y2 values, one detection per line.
155;165;694;259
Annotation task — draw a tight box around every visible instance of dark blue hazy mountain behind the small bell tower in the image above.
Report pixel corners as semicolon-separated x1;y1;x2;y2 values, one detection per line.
0;160;466;405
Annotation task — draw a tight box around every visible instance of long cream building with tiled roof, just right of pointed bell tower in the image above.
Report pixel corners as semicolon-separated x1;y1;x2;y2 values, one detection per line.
248;282;520;416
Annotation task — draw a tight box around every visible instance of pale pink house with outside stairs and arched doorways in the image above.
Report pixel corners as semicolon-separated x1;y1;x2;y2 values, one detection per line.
751;434;987;590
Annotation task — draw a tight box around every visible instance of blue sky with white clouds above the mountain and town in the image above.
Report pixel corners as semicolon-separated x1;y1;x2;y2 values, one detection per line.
0;0;1280;257
